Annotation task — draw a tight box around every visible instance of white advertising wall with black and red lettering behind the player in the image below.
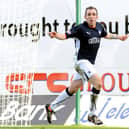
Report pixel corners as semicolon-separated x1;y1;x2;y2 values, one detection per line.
0;0;129;95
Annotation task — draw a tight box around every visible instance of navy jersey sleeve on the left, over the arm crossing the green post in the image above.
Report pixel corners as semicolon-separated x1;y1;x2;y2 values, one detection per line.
65;26;80;38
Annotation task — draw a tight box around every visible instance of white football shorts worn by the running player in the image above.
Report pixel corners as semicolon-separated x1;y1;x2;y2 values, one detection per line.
73;59;96;81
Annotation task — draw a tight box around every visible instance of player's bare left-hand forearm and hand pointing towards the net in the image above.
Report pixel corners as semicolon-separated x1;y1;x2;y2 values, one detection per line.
48;31;66;40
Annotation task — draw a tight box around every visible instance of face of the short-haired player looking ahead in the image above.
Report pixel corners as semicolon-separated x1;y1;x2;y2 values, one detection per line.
85;9;98;27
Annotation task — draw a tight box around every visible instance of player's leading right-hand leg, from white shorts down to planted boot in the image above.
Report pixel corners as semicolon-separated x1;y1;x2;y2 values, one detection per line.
76;60;103;125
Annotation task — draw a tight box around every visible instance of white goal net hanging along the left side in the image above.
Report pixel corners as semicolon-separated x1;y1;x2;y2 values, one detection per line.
0;0;39;126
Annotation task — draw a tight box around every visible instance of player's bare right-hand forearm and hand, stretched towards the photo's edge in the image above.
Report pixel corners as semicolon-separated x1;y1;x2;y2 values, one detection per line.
104;33;129;41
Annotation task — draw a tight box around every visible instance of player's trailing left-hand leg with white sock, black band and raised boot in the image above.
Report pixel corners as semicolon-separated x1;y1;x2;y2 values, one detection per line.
46;73;82;123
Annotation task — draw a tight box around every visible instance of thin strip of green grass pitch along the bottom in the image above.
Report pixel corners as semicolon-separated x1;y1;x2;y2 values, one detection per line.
0;125;129;129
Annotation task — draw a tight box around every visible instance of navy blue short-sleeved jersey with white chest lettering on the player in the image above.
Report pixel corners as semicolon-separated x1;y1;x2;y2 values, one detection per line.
66;22;107;64
